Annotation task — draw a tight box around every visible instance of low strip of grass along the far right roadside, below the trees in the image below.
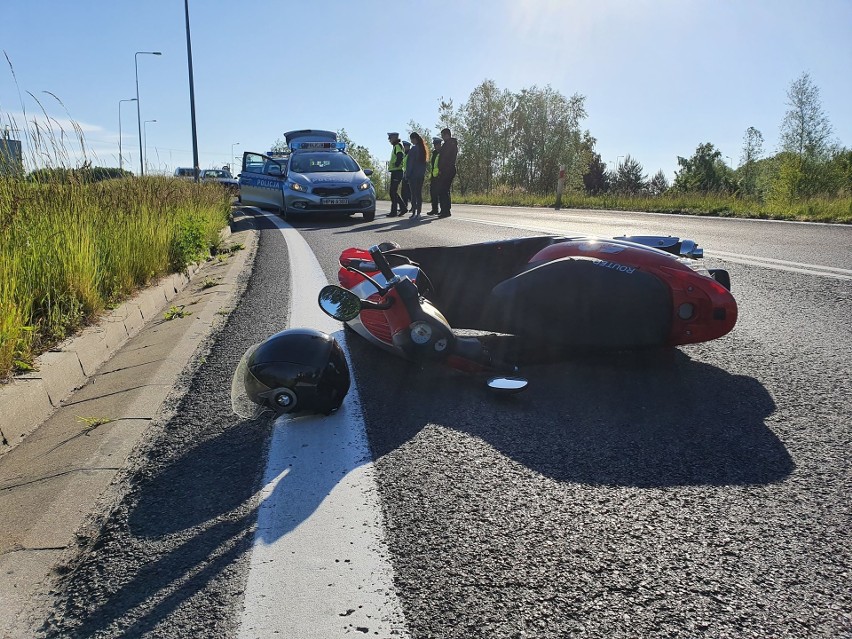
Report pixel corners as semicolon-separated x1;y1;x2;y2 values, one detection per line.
453;190;852;224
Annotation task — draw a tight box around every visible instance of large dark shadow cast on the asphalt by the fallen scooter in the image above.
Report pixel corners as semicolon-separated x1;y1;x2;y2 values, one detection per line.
349;339;794;487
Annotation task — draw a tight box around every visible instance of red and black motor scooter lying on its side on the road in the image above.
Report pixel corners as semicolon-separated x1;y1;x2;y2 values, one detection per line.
319;236;737;391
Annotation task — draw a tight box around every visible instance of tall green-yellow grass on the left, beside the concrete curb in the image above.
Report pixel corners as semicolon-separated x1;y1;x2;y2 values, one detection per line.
0;177;229;380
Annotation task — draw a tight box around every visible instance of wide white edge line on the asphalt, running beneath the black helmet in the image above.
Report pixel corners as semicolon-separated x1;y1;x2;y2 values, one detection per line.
239;215;408;639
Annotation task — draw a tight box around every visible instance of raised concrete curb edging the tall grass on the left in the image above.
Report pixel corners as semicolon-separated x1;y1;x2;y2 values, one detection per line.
0;225;231;457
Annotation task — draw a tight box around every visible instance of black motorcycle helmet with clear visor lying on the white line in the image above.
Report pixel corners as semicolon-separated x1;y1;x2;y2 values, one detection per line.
232;328;349;417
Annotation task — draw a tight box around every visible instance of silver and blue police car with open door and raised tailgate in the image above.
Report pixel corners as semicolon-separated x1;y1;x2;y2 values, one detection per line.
239;129;376;222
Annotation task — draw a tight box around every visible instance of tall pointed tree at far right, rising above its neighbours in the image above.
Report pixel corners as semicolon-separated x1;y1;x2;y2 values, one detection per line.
781;73;832;159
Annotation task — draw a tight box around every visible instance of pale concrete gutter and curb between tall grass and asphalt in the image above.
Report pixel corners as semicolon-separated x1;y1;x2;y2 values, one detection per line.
0;215;257;636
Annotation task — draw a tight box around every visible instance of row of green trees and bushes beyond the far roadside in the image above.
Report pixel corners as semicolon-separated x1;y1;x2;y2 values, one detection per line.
338;73;852;202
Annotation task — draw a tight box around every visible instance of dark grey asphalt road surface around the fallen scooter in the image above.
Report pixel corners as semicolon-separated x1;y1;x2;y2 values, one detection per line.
44;206;852;638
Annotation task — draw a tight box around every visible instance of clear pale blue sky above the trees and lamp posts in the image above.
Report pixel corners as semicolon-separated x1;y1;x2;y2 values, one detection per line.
0;0;852;178
